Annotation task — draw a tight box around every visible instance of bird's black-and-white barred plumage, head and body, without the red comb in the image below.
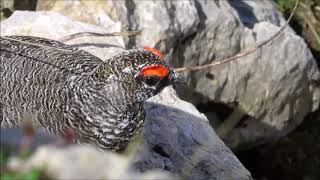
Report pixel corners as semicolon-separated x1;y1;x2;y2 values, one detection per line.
0;36;176;150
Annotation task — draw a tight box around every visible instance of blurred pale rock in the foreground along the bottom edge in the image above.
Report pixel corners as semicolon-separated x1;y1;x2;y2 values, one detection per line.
8;145;177;180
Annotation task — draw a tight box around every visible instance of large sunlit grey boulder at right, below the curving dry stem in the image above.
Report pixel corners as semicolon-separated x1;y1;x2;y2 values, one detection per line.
221;22;320;147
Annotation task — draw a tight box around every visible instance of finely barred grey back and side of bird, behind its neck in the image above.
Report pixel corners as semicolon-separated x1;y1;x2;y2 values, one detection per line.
0;36;102;133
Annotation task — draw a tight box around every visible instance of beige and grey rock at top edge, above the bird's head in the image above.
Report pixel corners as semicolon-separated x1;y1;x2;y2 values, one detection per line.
37;0;199;49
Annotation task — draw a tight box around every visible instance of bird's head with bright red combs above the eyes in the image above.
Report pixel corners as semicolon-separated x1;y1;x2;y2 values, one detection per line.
93;47;179;102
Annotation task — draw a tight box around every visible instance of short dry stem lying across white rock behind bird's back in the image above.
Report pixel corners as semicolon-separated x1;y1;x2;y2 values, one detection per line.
59;30;142;42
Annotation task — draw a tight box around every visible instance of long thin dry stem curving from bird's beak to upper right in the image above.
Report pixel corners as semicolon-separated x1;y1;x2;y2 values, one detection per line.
175;0;299;72
